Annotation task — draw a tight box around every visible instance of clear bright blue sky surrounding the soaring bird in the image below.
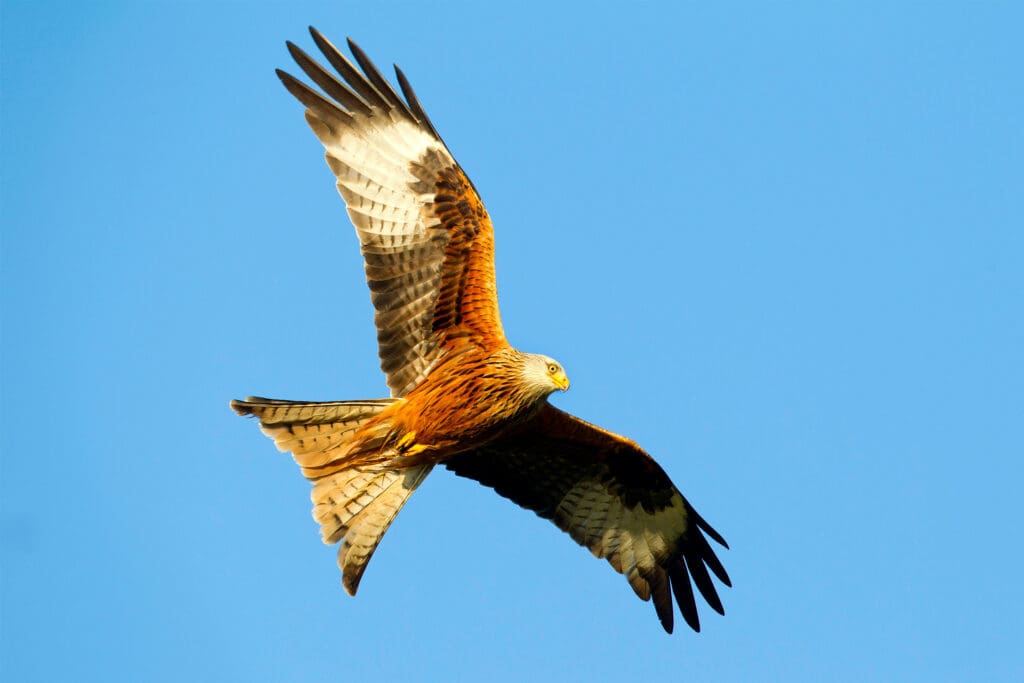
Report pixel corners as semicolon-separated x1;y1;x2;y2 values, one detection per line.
0;1;1024;681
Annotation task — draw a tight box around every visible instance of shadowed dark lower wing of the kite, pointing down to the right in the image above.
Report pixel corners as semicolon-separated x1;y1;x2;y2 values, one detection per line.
444;404;731;633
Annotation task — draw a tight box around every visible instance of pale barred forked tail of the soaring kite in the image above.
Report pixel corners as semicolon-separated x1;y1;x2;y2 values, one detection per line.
231;396;433;595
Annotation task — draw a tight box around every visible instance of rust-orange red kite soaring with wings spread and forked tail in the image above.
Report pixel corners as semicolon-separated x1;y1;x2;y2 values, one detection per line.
231;28;731;633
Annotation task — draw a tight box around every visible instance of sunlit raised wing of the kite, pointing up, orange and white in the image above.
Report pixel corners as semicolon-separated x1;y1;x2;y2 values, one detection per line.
278;28;507;396
